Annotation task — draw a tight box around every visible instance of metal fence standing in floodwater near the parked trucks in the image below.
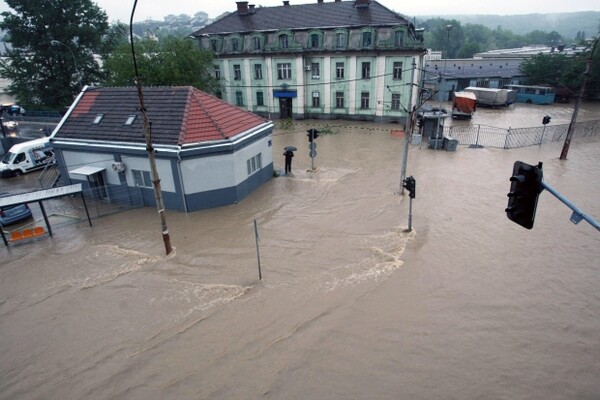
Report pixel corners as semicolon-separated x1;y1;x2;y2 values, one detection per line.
444;120;600;149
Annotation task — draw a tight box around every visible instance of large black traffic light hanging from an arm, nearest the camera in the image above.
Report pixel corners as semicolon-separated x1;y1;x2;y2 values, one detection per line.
505;161;544;229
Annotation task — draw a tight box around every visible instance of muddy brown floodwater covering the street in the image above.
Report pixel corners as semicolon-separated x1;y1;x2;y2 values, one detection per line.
0;104;600;400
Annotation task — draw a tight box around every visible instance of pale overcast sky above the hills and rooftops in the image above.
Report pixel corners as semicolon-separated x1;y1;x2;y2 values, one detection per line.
0;0;600;22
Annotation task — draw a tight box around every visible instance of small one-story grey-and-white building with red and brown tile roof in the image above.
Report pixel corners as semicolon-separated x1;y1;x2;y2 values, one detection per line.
50;86;273;211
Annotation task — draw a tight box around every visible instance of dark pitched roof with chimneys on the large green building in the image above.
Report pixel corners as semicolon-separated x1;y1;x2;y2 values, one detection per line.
192;0;409;36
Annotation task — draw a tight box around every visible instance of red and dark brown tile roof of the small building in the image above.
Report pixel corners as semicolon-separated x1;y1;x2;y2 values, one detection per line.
54;86;267;146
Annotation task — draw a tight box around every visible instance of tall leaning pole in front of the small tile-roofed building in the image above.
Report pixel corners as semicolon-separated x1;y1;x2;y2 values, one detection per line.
129;0;173;255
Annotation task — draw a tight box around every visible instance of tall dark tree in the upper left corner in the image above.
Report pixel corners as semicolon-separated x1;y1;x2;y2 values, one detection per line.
0;0;110;109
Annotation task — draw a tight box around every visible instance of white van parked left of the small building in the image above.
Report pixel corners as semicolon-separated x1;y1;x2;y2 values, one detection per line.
0;138;54;178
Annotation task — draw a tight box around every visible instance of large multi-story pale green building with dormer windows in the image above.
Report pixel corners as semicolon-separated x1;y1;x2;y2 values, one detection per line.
192;0;426;122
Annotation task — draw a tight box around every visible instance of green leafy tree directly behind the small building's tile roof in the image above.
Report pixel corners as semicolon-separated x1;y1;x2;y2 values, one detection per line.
104;36;215;92
